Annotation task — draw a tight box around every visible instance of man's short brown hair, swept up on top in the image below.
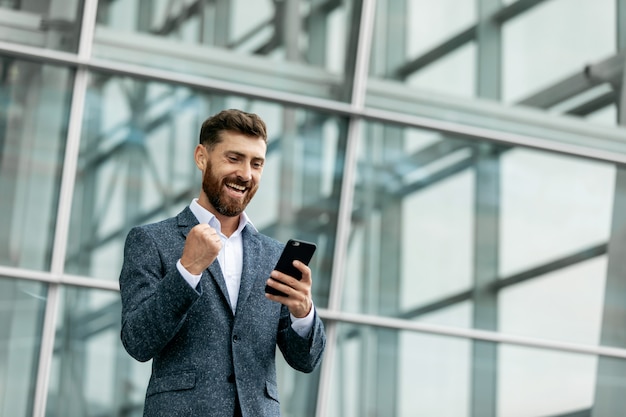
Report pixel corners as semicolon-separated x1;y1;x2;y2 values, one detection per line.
200;109;267;148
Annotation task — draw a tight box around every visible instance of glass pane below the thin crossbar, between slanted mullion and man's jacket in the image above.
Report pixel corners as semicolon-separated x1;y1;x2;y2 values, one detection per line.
46;287;150;417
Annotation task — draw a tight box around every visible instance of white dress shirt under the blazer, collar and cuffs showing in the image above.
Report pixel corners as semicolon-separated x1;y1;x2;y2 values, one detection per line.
176;198;315;337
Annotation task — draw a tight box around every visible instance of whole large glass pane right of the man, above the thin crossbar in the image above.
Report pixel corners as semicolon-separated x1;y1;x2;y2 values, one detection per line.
342;119;621;345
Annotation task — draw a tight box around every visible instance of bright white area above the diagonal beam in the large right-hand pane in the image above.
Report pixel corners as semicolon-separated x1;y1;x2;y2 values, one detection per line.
499;148;615;277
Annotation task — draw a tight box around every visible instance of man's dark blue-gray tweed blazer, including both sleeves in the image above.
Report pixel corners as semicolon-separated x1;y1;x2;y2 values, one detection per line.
119;207;326;417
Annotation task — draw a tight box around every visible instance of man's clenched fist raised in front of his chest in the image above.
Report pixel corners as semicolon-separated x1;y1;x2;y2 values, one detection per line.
180;224;222;275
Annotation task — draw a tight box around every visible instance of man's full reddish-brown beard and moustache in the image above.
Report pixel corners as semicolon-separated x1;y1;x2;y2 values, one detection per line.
202;162;259;217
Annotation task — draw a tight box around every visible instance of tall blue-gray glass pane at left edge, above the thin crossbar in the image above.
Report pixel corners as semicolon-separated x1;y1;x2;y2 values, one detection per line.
0;56;73;270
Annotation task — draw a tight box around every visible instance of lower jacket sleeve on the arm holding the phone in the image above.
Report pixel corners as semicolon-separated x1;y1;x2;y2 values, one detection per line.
277;306;326;373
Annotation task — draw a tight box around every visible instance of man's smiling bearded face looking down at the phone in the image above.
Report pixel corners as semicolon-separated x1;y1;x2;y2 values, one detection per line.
195;131;267;218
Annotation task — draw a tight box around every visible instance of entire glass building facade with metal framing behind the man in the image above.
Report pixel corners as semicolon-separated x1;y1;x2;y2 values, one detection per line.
0;0;626;417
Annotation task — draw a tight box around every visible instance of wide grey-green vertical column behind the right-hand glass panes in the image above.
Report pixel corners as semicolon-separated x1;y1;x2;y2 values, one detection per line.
470;0;502;417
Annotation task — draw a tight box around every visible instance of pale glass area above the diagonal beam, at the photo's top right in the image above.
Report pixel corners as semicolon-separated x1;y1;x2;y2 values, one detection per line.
502;0;617;102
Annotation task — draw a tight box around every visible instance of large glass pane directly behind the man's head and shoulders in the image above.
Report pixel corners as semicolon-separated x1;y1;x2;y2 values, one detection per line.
67;74;346;306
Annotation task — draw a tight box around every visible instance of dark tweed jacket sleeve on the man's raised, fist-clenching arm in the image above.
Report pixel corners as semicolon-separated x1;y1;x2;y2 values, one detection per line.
119;227;200;362
